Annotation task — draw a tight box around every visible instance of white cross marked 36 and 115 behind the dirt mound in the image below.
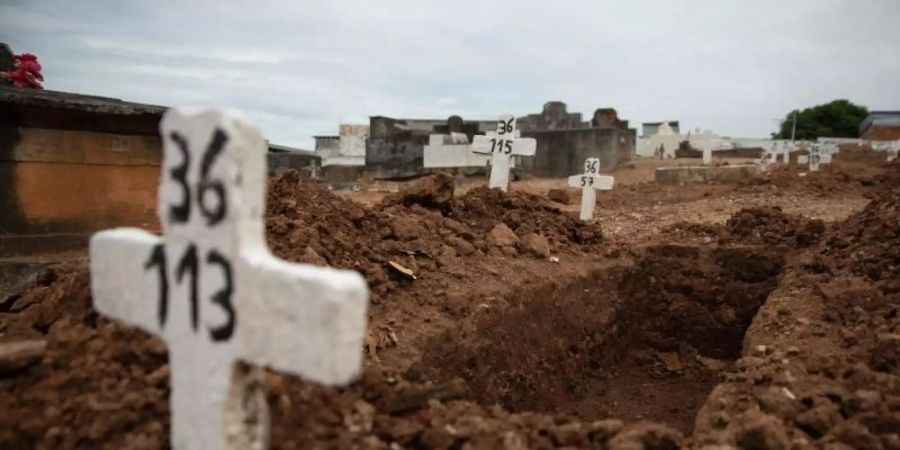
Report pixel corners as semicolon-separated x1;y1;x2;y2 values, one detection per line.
472;114;537;191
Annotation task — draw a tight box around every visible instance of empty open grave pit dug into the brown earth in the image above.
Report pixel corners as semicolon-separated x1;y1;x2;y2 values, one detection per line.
410;246;784;432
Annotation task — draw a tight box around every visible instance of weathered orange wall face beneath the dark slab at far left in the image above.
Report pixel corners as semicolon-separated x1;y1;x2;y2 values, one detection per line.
0;126;161;255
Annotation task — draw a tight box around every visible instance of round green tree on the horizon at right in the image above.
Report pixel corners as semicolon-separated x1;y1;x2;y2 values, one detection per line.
772;100;869;140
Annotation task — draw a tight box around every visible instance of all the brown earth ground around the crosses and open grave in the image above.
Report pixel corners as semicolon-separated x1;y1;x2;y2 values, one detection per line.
0;156;900;449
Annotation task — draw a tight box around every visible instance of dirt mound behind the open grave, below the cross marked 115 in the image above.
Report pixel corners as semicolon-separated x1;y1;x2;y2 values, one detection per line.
266;172;603;301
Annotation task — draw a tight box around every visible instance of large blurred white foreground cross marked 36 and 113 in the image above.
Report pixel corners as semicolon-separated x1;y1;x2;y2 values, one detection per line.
90;109;368;450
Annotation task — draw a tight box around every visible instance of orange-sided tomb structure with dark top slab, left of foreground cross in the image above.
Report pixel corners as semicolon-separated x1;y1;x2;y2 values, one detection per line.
0;88;164;256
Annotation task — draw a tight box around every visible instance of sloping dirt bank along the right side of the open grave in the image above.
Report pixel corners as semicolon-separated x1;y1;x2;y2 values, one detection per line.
692;169;900;449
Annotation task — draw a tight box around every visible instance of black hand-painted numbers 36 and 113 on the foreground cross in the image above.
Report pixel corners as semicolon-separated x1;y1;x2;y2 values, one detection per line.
144;129;236;342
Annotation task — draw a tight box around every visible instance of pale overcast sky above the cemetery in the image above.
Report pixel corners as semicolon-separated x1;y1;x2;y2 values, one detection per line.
0;0;900;149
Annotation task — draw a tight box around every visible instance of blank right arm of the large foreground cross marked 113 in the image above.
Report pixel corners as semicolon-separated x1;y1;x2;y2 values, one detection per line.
237;254;369;385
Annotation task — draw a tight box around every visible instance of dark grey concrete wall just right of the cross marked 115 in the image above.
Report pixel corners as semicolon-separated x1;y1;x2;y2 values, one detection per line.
522;127;635;177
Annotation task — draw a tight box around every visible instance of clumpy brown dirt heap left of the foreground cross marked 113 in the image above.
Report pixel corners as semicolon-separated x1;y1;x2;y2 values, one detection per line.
0;268;169;449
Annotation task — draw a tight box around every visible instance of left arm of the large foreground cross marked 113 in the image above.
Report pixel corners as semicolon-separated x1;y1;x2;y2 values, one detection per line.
90;228;167;335
